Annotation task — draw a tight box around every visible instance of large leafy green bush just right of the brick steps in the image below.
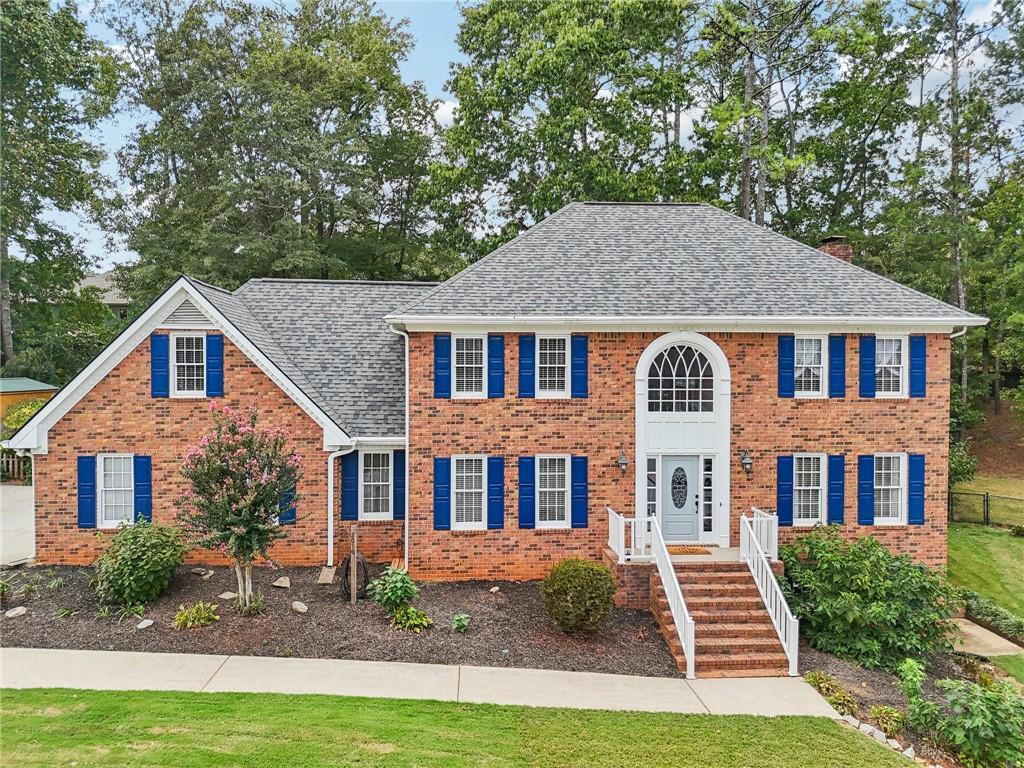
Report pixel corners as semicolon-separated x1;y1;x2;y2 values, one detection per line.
779;525;958;669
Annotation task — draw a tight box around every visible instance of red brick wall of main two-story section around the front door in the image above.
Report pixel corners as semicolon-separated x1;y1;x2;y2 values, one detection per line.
409;333;949;580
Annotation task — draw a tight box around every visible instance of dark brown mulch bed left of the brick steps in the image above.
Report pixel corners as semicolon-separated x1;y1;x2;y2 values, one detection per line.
0;566;680;677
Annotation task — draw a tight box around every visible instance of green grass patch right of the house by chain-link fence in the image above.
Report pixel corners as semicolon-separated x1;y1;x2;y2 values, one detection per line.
948;523;1024;616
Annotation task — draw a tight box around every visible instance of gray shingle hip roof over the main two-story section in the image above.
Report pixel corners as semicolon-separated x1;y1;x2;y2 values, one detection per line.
394;203;979;324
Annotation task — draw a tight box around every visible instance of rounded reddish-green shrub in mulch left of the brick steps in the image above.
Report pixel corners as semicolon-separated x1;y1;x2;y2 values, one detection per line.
542;558;615;634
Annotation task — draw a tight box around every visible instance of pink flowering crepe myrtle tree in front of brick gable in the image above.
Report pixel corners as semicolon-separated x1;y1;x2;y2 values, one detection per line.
178;403;302;608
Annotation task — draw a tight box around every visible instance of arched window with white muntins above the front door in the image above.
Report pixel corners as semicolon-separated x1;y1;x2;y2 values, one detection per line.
647;344;715;414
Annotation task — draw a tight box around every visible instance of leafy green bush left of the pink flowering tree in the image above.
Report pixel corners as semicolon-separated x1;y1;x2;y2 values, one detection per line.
94;520;188;605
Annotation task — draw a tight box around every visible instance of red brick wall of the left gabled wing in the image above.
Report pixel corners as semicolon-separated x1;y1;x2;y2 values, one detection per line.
35;339;402;565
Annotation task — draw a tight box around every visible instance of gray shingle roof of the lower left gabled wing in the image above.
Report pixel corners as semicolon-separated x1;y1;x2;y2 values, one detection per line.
191;279;433;437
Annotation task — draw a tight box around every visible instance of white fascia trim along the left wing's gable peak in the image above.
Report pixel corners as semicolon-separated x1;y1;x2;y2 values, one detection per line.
7;278;352;454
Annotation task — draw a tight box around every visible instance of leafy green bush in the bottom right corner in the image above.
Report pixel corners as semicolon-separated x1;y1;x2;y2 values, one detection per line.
899;658;1024;768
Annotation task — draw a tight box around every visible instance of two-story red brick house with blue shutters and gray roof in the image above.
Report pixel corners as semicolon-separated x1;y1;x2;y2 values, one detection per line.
9;203;985;673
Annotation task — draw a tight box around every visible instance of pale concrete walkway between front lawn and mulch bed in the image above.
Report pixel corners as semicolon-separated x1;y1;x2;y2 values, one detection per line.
0;648;839;718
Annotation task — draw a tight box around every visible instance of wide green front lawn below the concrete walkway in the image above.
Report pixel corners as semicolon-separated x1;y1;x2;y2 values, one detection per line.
0;689;905;768
